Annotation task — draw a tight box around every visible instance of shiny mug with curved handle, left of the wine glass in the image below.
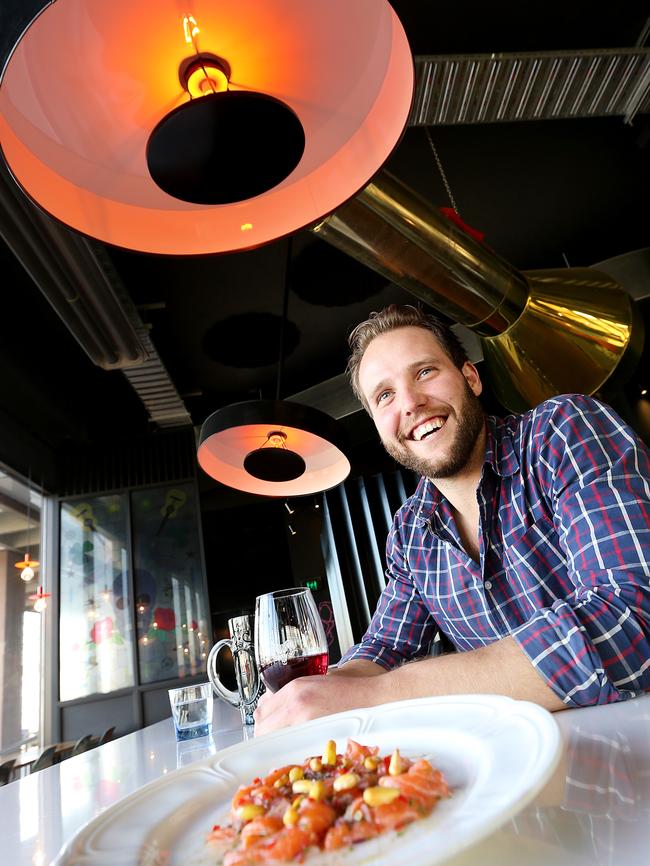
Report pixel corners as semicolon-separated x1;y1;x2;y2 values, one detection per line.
208;616;264;726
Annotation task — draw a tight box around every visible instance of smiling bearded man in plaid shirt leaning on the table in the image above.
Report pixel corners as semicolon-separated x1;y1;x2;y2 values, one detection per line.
256;306;650;733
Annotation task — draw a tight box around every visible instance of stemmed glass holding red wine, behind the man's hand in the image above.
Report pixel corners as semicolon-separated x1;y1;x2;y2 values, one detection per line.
255;587;329;692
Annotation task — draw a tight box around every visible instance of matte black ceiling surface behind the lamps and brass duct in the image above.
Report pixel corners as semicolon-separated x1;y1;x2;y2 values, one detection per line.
0;0;650;492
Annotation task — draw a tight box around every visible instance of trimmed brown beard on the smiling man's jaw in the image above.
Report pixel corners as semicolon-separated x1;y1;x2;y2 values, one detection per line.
382;382;485;480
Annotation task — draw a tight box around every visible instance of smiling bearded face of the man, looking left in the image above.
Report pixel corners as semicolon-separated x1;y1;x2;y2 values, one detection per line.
359;327;485;479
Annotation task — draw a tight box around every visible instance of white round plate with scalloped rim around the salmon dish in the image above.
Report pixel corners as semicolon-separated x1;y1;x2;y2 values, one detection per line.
53;695;560;866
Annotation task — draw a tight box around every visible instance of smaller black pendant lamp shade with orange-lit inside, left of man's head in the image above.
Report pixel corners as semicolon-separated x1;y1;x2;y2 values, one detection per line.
198;400;350;497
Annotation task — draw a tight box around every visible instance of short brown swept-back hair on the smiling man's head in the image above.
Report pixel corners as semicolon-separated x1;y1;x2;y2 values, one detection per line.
347;304;469;412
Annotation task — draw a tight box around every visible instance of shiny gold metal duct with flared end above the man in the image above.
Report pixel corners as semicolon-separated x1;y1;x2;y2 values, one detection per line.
313;172;643;412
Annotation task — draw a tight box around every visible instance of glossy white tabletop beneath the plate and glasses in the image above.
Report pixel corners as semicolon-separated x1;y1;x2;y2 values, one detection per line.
0;694;650;866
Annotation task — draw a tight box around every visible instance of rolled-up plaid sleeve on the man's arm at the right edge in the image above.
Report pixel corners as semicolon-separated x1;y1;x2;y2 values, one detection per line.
513;396;650;706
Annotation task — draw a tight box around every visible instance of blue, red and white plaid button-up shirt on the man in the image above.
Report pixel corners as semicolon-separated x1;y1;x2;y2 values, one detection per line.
342;395;650;706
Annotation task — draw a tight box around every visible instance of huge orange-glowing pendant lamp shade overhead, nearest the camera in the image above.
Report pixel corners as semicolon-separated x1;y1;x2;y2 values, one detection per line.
0;0;414;255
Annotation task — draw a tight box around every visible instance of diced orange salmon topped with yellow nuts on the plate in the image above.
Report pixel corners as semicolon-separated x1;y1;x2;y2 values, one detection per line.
207;740;450;866
